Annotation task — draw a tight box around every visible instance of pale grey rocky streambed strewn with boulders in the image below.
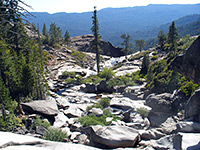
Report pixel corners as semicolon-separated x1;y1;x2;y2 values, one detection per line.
0;45;200;150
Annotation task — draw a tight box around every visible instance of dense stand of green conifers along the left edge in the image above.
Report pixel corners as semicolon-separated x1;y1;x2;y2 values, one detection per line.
0;1;47;131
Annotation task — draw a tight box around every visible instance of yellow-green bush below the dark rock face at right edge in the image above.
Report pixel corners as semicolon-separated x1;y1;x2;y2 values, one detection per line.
179;77;199;97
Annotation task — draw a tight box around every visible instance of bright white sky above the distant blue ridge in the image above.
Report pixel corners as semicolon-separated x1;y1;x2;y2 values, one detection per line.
23;0;200;14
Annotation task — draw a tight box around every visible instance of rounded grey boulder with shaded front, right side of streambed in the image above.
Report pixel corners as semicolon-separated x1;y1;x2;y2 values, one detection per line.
146;93;172;113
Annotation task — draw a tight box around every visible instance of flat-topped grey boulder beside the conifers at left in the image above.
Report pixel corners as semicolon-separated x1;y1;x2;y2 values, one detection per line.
21;100;59;116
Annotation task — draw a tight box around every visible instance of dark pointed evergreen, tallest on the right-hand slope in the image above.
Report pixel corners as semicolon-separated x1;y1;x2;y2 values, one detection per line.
168;21;178;44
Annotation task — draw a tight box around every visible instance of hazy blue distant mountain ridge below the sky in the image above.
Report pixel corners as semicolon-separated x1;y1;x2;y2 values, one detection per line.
29;4;200;45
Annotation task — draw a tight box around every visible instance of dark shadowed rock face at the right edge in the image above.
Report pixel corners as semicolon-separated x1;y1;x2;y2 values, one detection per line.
171;36;200;84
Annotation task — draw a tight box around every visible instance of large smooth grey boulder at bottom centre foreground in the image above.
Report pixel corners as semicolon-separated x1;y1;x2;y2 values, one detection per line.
82;126;139;148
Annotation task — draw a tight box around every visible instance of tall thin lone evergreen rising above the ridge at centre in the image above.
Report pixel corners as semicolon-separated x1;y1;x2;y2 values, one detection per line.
91;7;100;73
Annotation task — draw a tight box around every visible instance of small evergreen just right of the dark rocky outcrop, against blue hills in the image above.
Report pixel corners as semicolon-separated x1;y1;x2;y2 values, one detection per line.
120;34;133;56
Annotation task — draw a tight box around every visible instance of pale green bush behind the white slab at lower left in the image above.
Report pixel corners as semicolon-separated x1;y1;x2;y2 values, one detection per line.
42;128;67;142
